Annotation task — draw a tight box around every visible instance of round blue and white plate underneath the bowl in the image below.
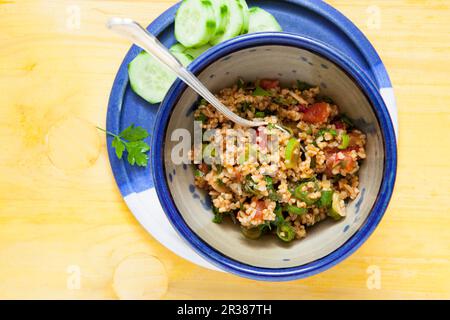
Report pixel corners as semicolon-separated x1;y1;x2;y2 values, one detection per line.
106;0;398;270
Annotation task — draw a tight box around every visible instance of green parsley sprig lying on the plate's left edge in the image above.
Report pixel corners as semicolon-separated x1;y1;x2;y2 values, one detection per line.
97;124;150;167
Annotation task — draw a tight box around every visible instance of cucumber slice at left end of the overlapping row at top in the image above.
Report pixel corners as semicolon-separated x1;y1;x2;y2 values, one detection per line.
175;0;216;48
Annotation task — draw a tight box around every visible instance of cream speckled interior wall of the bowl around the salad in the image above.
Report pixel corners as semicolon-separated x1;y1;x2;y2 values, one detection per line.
164;45;384;268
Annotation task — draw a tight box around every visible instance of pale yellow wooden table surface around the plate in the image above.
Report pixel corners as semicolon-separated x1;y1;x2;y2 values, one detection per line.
0;0;450;299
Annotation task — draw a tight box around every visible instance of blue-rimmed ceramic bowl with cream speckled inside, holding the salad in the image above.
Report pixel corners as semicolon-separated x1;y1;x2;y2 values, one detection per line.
151;33;397;281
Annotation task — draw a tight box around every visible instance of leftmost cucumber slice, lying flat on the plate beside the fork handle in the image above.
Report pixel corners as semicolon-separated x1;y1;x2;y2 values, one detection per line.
128;51;177;103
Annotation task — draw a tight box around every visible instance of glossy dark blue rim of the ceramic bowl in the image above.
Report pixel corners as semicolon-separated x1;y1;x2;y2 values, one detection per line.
151;33;397;281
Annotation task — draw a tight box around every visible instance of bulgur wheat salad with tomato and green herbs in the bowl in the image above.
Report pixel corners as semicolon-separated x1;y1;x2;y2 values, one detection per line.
195;79;366;242
